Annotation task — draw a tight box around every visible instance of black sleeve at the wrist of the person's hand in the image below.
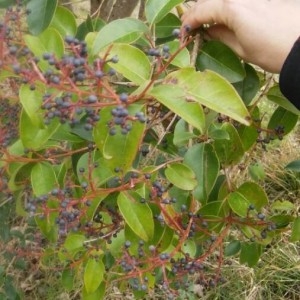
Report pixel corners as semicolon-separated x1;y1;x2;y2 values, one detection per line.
279;38;300;109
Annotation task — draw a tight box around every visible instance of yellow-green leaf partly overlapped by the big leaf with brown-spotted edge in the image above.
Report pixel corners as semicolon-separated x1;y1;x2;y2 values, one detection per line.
150;84;205;132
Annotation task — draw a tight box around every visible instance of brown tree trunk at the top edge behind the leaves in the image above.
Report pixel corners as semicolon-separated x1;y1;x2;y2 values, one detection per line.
90;0;139;22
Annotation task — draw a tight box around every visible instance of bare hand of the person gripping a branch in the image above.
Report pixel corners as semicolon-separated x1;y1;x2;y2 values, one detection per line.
182;0;300;73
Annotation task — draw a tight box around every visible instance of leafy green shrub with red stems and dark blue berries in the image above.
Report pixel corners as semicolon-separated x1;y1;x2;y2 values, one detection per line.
0;0;299;299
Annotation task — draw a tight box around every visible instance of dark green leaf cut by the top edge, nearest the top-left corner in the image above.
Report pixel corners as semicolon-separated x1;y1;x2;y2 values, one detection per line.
27;0;57;35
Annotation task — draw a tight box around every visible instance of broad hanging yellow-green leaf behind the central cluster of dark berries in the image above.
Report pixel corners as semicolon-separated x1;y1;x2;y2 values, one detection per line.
93;104;146;172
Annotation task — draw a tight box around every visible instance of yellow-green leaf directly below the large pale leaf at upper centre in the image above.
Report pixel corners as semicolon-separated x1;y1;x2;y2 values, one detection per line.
109;44;151;85
